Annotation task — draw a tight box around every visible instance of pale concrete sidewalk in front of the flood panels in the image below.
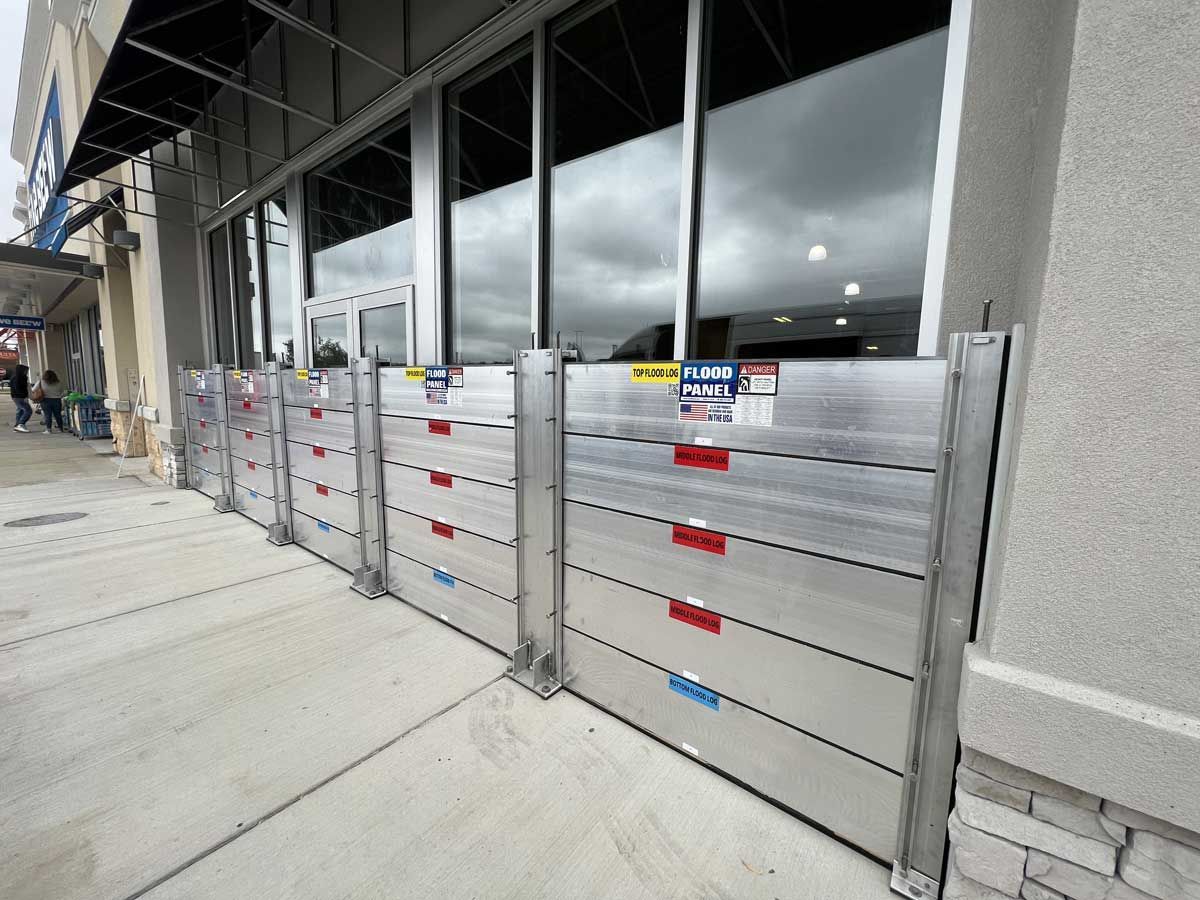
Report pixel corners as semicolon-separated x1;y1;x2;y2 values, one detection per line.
0;431;888;900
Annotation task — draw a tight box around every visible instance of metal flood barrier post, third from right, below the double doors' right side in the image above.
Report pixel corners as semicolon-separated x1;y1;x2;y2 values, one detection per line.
350;356;386;596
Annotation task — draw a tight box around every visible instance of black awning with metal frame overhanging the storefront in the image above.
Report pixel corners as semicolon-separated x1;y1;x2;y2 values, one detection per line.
56;0;404;196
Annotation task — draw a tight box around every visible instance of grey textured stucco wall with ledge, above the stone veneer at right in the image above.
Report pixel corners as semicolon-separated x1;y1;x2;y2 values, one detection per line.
960;0;1200;829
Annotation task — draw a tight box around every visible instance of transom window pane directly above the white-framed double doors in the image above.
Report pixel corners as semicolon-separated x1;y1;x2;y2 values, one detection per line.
307;118;413;295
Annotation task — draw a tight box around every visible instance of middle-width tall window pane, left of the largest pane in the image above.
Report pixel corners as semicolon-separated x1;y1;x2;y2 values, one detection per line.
551;0;688;360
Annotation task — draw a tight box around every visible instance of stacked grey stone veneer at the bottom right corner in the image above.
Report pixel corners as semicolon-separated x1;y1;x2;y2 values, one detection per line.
943;748;1200;900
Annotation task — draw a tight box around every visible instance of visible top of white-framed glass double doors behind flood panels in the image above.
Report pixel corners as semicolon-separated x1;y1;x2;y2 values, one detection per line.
305;287;413;368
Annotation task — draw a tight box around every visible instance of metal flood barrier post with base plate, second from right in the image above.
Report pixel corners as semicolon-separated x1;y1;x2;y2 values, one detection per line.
510;349;563;697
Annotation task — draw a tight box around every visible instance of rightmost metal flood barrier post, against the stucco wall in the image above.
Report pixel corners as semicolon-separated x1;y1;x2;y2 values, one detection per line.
892;331;1006;900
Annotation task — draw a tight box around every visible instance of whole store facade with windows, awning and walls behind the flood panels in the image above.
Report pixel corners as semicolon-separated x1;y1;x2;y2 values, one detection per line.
5;0;1200;900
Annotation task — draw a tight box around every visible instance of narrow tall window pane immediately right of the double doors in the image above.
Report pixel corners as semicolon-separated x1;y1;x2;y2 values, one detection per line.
446;48;533;362
